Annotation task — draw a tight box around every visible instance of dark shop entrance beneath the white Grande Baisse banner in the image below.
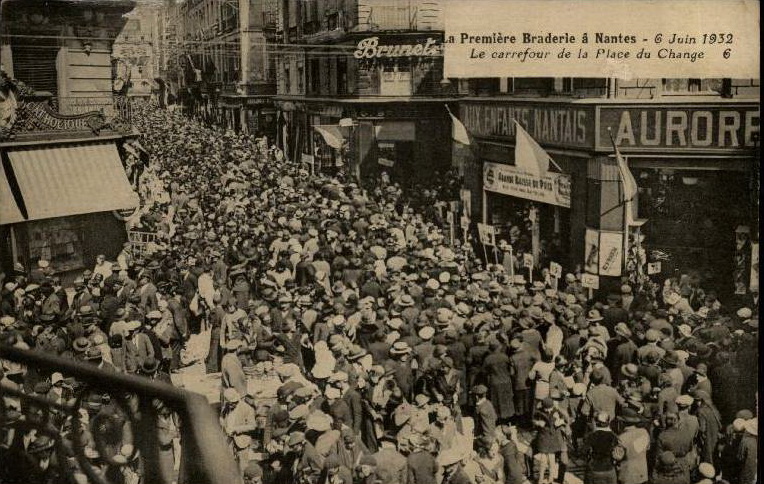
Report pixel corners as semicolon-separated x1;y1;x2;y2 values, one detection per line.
485;192;570;268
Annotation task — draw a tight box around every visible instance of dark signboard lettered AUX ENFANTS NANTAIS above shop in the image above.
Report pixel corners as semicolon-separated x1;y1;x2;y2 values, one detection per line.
459;101;594;148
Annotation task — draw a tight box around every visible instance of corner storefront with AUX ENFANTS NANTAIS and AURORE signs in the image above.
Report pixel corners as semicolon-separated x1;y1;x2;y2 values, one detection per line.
459;98;759;293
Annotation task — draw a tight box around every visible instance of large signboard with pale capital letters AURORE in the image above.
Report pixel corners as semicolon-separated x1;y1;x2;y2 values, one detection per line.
598;104;761;150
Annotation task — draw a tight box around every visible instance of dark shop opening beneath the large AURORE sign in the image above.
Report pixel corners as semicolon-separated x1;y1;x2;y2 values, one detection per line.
634;168;756;295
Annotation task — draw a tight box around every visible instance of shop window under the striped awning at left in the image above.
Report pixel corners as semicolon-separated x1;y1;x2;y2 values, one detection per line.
27;218;84;272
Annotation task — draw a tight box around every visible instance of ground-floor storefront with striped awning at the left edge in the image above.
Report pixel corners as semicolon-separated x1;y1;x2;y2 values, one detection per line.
0;102;139;277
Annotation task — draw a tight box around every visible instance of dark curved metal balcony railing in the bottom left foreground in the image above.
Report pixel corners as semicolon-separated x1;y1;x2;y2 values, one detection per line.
0;344;242;484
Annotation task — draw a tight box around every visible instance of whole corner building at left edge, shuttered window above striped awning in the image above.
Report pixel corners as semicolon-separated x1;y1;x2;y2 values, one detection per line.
0;1;138;276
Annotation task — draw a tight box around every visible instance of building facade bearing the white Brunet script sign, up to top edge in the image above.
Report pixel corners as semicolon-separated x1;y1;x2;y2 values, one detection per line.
275;0;454;184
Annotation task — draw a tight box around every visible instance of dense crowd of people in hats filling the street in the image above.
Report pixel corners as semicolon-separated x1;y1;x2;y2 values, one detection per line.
0;103;758;482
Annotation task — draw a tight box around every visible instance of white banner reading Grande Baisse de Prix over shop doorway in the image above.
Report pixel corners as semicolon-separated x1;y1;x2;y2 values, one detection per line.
483;162;570;208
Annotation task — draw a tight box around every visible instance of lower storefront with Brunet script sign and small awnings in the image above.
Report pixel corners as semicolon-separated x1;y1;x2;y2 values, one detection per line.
276;32;451;183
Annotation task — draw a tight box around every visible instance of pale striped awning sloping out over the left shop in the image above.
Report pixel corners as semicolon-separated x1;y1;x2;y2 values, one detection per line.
0;142;138;224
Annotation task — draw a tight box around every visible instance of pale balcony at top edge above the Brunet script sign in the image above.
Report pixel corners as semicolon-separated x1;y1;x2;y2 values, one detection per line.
354;0;444;32
